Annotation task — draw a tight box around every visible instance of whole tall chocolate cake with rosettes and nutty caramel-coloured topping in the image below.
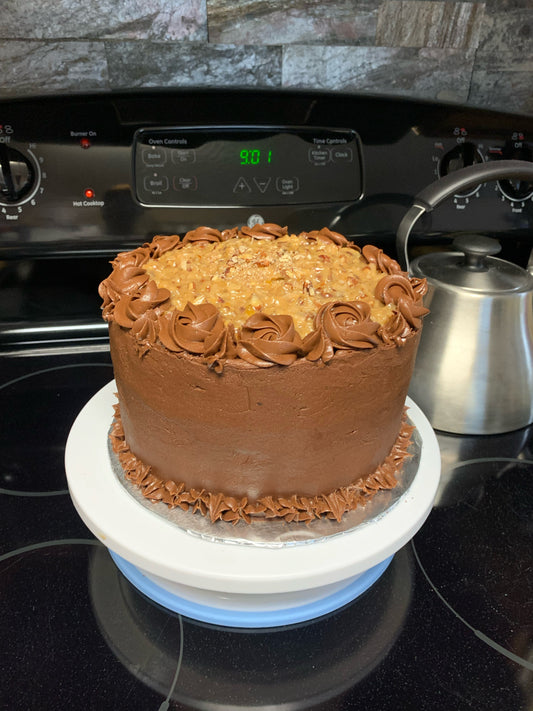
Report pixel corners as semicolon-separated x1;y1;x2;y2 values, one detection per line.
100;224;427;522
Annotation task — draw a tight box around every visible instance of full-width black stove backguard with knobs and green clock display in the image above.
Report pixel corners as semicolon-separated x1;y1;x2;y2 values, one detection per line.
0;89;533;262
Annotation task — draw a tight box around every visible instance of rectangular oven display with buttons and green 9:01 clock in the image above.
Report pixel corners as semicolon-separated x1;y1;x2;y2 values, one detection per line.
134;126;363;207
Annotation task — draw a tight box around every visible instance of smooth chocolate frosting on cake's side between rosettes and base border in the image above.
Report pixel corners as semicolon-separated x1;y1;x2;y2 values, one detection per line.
110;322;418;516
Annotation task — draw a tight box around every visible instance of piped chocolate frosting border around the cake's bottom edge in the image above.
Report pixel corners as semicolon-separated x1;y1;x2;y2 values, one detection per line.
109;403;415;524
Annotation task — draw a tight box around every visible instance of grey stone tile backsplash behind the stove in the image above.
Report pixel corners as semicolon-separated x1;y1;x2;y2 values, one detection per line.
0;0;533;114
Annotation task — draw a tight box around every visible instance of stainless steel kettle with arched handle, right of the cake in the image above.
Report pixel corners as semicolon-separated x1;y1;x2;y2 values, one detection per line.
396;160;533;435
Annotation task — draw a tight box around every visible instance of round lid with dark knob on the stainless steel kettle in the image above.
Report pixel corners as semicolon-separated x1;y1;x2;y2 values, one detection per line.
411;234;533;294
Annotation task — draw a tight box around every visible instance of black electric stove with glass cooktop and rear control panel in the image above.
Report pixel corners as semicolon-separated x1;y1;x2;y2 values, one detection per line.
0;89;533;711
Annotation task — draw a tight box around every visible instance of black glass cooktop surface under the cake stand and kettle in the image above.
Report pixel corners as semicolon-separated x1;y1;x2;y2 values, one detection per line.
0;350;533;711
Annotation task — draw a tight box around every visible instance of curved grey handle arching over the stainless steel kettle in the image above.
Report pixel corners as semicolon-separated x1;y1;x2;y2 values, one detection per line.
396;160;533;271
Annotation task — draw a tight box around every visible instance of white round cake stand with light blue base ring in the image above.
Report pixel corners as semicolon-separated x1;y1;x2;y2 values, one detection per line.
65;381;440;628
